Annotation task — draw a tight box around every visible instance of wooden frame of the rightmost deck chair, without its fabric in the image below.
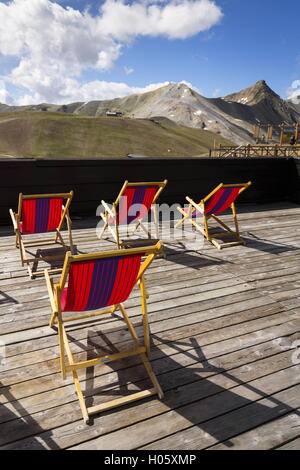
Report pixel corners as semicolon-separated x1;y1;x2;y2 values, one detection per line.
175;181;252;250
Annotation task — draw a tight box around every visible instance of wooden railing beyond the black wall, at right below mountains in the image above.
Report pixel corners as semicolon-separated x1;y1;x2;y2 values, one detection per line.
209;144;300;158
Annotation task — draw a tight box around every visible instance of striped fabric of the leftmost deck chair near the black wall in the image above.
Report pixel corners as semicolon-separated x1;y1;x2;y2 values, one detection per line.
20;198;63;234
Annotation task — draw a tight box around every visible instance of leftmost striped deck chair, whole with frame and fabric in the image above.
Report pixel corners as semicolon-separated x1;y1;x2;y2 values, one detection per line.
9;191;74;279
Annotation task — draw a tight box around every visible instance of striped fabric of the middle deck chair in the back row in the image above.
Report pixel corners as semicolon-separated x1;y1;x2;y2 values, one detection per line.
115;186;158;225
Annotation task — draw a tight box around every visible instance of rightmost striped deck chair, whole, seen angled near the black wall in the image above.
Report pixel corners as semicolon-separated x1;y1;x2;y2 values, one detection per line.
175;181;252;250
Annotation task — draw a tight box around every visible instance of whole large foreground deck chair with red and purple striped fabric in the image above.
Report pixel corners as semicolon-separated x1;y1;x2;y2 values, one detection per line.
45;242;163;423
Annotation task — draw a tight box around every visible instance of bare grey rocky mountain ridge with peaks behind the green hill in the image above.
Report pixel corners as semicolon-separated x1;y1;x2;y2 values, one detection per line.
0;80;300;144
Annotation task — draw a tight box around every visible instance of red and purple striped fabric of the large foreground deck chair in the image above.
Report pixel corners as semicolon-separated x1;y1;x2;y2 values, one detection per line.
61;255;141;312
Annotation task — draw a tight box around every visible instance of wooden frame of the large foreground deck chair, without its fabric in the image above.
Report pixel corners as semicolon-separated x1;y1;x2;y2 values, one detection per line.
44;242;163;423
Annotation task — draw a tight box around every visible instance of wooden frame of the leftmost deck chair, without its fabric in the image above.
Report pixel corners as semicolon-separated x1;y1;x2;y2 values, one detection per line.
9;191;74;279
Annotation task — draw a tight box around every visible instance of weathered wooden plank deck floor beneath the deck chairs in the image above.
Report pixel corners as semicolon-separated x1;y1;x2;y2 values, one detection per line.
0;203;300;450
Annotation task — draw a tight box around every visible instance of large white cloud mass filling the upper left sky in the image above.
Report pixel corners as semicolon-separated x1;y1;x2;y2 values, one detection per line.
0;0;222;103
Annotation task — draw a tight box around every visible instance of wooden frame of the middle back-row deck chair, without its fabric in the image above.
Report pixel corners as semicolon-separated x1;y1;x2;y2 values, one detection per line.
99;180;168;249
